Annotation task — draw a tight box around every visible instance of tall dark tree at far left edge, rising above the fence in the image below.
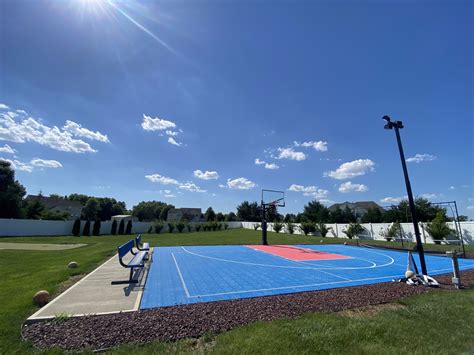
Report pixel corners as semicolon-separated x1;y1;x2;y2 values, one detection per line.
0;160;26;218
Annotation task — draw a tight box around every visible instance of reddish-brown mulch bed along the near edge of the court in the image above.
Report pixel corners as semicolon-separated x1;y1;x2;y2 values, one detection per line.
22;270;474;350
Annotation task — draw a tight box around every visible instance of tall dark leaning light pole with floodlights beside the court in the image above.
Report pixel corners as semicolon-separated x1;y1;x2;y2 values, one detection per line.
382;116;428;275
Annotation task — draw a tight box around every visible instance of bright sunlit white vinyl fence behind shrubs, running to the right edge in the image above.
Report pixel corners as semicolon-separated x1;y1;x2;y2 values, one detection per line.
241;222;474;245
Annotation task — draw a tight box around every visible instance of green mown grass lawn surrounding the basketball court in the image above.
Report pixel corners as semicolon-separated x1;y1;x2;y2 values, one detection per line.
0;229;474;354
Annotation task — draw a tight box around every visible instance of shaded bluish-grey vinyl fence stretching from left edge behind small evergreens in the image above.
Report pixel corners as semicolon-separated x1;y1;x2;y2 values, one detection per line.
0;218;242;237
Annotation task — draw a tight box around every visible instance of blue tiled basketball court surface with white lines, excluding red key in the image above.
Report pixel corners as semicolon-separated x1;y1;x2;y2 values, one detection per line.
140;245;474;309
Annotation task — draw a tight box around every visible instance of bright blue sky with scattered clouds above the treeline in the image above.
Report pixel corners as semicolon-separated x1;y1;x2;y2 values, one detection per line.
0;0;474;218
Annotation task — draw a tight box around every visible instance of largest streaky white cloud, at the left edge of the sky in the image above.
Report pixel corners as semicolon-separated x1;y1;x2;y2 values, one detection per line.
0;112;105;153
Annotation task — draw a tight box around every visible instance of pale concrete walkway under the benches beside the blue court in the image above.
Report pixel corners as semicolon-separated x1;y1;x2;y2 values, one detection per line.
26;250;150;323
